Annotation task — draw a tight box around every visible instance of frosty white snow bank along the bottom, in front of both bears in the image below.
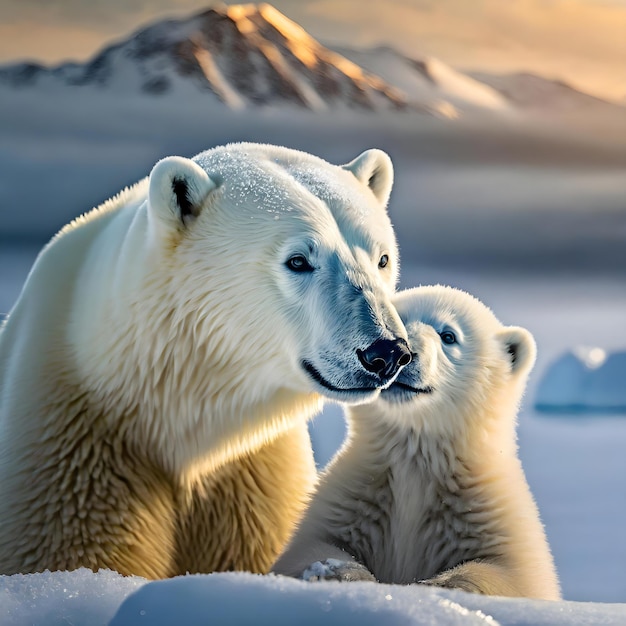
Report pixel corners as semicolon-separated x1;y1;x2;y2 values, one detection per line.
0;569;626;626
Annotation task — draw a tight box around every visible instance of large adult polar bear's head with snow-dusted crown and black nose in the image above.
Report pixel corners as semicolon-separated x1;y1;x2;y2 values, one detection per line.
147;144;411;403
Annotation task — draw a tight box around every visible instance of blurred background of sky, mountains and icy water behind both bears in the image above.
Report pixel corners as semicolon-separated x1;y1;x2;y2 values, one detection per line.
0;0;626;602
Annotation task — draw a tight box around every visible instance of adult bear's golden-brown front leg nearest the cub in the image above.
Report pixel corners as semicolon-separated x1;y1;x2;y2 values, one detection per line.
173;420;316;575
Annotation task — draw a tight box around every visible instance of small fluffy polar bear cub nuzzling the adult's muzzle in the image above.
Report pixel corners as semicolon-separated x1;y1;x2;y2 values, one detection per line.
273;286;560;600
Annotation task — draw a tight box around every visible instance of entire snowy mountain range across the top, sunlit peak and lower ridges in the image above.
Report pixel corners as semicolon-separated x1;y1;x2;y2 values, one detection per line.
0;4;626;120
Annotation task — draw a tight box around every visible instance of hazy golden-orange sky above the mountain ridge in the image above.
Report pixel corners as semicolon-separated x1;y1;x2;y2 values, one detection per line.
0;0;626;102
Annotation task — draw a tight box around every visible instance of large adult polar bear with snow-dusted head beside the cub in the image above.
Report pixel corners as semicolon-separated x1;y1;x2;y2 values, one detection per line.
0;144;411;578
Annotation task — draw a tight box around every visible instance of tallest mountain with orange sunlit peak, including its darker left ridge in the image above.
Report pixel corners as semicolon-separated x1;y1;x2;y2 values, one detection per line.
0;4;413;110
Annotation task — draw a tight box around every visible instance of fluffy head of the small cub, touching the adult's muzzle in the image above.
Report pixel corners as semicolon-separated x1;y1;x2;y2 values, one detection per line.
366;285;536;431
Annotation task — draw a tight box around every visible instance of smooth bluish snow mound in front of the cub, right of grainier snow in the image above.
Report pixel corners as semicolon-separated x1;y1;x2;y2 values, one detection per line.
111;574;626;626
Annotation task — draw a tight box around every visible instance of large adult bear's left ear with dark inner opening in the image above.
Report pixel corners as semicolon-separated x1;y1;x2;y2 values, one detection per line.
148;157;218;227
